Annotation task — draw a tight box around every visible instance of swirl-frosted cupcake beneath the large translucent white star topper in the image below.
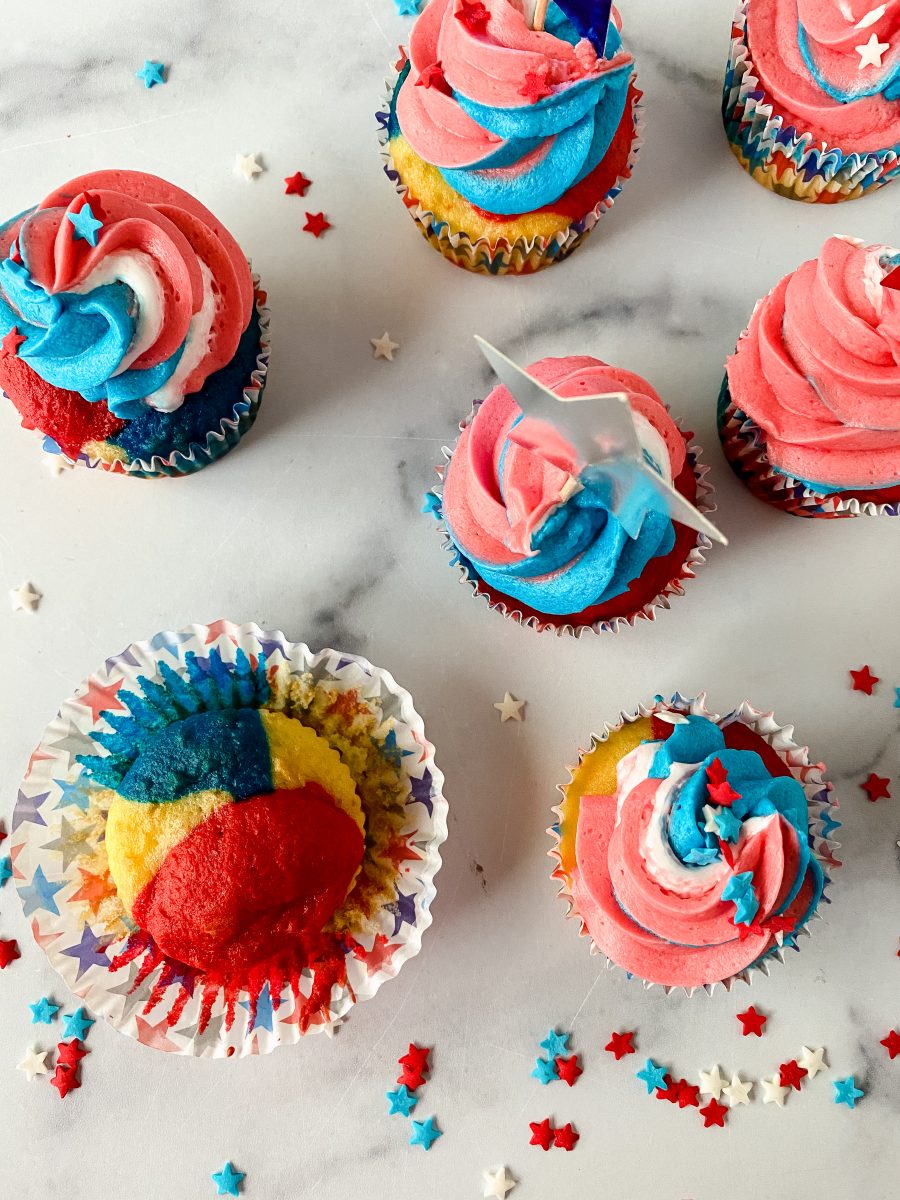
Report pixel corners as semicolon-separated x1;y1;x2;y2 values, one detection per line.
426;356;715;635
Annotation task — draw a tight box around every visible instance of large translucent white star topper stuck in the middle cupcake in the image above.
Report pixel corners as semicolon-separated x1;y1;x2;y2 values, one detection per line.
475;336;728;546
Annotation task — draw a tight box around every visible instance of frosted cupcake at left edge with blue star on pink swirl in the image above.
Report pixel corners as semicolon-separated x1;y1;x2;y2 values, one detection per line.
0;170;269;476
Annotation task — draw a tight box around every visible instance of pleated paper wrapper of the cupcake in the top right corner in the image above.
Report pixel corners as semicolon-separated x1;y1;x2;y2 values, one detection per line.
722;0;900;203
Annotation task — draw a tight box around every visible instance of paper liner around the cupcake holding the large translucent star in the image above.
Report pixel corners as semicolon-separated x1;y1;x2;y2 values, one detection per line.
428;400;716;637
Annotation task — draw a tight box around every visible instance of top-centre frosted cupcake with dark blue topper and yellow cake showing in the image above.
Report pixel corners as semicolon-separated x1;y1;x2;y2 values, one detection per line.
378;0;641;275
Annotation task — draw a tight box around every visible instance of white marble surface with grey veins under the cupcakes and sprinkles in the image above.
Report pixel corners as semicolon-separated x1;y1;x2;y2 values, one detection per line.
0;0;900;1200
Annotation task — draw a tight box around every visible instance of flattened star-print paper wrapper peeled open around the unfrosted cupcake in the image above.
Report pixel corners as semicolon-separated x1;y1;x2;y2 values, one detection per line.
11;622;448;1057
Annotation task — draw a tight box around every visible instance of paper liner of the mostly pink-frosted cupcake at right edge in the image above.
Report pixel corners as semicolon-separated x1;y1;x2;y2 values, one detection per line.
718;374;900;520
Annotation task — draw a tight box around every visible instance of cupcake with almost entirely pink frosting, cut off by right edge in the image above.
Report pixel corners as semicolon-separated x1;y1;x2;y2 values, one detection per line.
719;238;900;517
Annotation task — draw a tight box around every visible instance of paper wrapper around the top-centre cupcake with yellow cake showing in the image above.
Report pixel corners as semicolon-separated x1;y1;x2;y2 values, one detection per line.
376;56;643;275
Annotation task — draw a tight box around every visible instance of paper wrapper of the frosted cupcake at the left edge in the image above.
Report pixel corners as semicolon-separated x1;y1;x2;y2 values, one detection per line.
32;275;271;479
